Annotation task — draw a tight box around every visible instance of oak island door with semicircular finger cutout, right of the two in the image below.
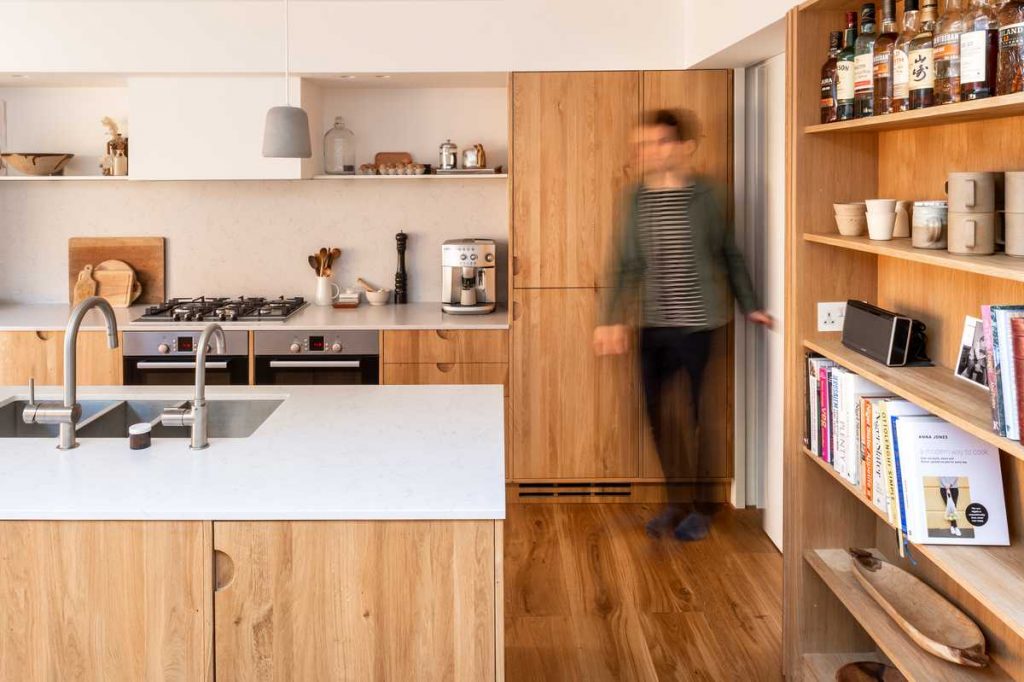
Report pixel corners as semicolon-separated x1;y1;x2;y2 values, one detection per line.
214;521;501;682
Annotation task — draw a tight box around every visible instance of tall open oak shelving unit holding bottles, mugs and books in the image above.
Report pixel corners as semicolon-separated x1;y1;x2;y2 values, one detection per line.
783;0;1024;680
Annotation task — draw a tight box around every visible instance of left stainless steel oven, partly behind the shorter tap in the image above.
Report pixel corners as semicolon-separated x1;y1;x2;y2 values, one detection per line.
124;330;249;386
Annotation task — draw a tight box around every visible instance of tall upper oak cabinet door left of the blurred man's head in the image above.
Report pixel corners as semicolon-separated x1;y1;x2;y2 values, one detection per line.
512;72;640;289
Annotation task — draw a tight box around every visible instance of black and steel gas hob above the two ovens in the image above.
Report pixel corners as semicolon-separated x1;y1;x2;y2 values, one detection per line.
135;296;306;323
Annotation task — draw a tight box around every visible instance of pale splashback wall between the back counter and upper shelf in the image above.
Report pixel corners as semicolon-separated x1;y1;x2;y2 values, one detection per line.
0;179;508;303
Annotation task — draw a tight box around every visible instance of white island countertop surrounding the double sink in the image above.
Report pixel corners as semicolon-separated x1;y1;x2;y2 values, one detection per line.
0;386;505;520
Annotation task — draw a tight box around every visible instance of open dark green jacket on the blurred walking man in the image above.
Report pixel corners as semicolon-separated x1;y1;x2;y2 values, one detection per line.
604;178;760;330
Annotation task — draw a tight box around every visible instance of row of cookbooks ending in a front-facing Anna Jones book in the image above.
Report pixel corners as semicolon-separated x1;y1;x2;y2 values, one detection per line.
805;355;1010;545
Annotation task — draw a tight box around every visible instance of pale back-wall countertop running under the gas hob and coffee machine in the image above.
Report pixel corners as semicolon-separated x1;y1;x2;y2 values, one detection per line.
0;301;509;332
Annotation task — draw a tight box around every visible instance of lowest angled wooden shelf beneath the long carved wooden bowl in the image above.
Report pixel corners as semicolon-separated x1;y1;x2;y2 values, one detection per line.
804;549;1012;682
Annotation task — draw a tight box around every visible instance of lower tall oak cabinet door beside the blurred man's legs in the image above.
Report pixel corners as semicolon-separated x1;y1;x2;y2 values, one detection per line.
512;289;640;480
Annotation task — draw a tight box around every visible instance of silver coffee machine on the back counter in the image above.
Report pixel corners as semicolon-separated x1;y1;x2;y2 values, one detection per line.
441;240;498;314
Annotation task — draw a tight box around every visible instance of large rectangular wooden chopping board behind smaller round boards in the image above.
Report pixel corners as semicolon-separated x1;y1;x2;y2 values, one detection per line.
68;237;165;303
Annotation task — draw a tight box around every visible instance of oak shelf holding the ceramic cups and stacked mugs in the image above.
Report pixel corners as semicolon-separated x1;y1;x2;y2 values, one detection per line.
804;232;1024;282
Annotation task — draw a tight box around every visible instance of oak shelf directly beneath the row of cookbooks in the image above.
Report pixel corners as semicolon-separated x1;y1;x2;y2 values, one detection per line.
804;447;1024;636
